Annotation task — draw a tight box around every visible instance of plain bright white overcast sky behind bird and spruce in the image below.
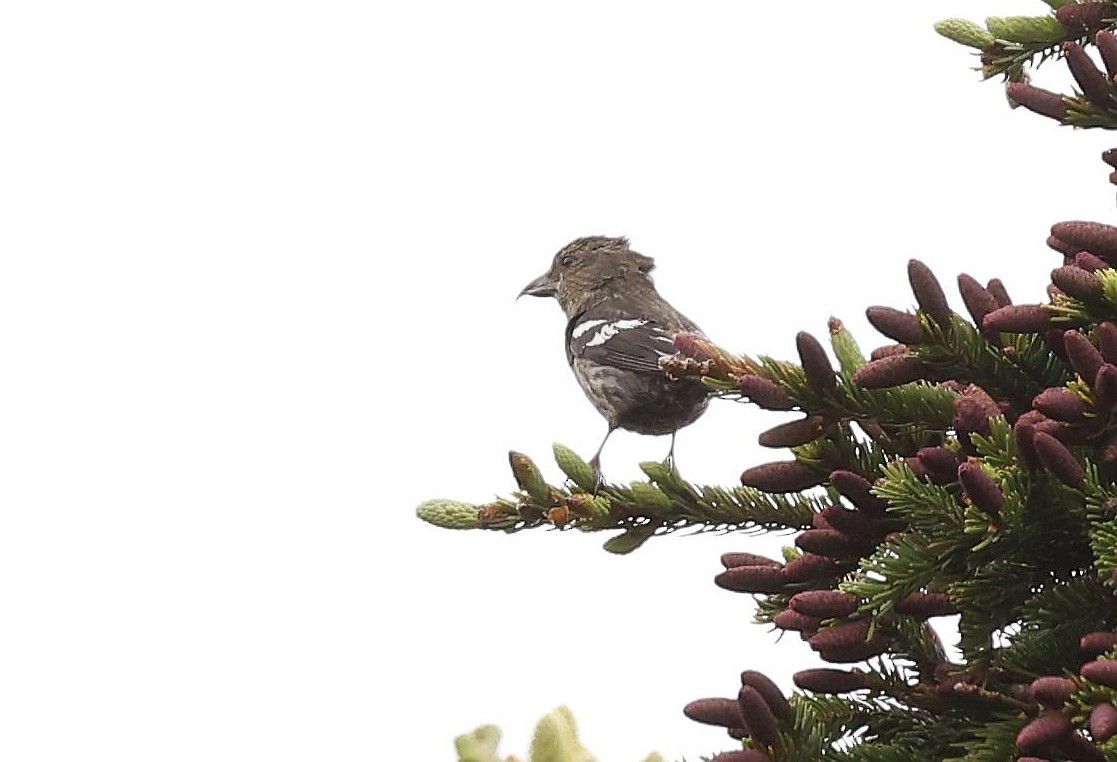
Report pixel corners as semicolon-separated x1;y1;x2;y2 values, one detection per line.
0;0;1114;762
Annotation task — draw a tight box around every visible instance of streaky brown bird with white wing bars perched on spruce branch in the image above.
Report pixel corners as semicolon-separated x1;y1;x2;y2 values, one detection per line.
517;236;709;484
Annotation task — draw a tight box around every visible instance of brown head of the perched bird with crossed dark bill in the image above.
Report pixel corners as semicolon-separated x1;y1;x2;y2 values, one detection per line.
519;236;656;315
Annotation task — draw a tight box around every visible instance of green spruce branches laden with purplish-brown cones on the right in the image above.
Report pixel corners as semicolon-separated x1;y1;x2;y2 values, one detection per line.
419;0;1117;762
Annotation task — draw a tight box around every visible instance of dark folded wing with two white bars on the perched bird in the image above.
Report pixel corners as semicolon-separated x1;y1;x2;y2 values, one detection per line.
566;315;675;373
